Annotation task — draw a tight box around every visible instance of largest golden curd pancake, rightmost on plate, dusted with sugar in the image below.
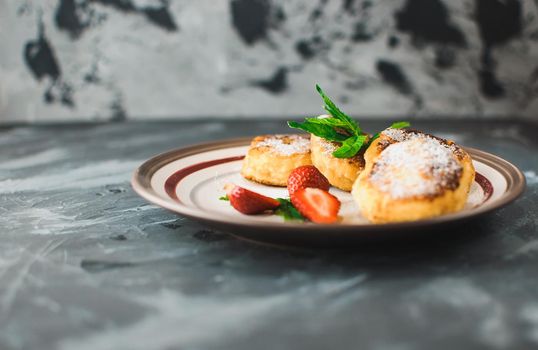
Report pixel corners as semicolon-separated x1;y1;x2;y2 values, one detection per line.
352;128;475;223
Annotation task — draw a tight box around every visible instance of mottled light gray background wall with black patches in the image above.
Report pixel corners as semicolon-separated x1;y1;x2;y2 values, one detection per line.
0;0;538;122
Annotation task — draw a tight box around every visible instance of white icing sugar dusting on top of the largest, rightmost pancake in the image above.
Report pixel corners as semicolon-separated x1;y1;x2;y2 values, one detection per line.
370;137;462;199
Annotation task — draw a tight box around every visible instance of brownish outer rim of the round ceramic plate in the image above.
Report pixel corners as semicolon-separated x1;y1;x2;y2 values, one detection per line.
131;137;526;232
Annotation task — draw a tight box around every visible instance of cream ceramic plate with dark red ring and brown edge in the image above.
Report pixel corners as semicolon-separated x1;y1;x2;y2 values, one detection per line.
132;138;525;245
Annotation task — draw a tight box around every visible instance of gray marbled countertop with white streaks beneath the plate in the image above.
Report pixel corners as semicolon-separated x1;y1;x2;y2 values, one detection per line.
0;120;538;350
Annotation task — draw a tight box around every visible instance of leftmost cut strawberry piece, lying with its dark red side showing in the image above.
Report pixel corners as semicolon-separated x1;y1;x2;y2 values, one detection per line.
224;184;280;215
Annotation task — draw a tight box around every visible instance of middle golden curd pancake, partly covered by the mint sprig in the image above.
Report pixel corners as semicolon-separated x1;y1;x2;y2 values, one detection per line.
310;135;365;192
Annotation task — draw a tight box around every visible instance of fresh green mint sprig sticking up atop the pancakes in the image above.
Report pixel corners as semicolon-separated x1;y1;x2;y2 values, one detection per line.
288;84;410;158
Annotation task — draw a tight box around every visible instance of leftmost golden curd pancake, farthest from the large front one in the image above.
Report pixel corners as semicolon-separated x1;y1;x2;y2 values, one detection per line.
241;134;312;186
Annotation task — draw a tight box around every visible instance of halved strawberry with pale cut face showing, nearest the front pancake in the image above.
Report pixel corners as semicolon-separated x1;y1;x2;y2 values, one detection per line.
291;188;340;224
